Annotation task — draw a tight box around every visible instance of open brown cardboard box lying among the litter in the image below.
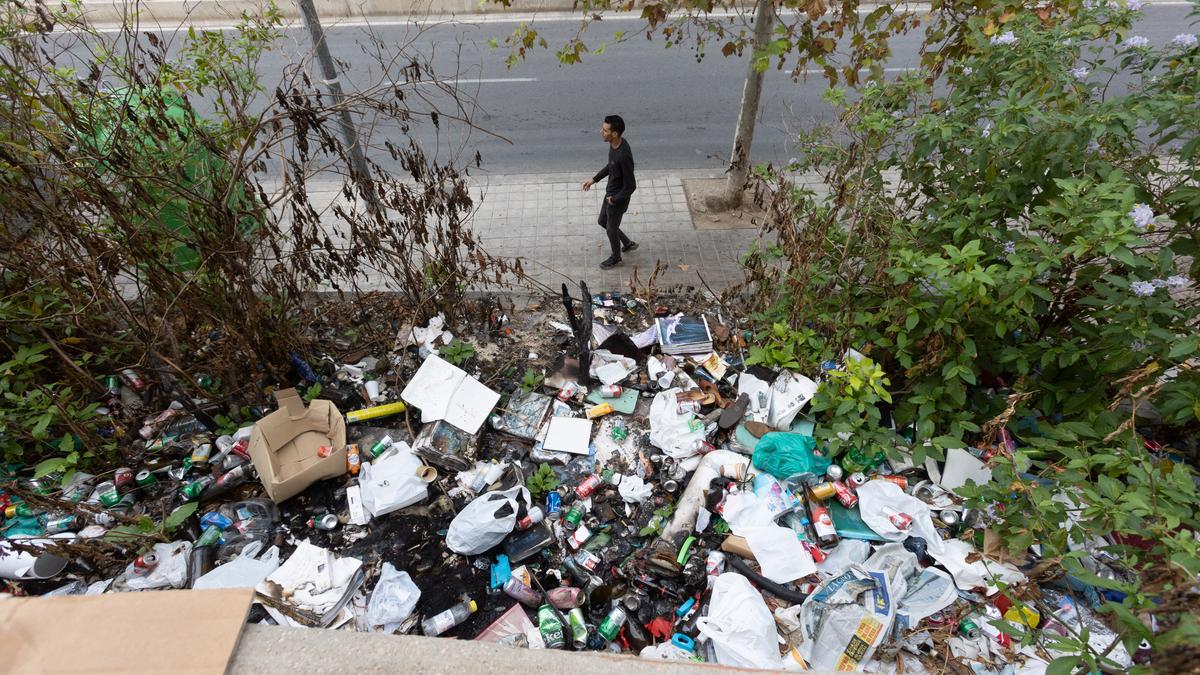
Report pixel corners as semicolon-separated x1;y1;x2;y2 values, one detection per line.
248;389;347;502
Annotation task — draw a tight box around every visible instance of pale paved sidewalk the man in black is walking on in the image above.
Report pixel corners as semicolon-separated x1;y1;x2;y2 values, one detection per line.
297;171;777;292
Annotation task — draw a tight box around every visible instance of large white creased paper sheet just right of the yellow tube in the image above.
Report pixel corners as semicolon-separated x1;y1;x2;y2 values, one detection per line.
400;354;500;434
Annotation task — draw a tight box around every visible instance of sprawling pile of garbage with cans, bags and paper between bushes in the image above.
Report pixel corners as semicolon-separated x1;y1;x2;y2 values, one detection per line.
0;287;1142;673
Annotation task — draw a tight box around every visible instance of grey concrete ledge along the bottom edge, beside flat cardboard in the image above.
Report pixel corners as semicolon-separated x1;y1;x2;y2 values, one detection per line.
228;626;787;675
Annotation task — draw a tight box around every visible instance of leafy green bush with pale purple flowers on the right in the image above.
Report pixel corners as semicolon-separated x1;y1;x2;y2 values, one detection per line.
746;0;1200;671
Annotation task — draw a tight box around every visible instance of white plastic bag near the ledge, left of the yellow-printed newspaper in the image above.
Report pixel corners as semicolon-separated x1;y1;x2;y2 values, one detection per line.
696;572;780;668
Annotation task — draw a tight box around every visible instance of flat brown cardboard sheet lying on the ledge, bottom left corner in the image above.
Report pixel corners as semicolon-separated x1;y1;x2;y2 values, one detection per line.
0;589;254;674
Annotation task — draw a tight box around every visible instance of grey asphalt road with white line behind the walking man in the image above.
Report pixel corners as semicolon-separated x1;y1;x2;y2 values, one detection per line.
87;4;1200;172
